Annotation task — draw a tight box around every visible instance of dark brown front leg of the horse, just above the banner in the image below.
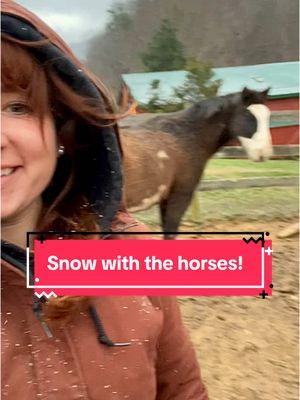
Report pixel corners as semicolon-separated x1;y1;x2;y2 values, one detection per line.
160;190;193;239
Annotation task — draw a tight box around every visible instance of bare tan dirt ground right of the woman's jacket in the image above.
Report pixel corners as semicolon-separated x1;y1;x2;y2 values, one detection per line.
180;220;299;400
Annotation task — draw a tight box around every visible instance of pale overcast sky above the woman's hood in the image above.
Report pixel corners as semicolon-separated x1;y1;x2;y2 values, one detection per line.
17;0;115;44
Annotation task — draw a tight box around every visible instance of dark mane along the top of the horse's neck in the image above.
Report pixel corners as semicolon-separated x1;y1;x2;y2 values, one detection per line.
142;93;241;132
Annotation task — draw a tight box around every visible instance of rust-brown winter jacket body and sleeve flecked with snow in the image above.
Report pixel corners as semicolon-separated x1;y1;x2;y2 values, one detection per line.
1;214;208;400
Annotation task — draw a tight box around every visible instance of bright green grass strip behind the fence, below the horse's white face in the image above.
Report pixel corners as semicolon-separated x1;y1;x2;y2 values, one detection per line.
204;159;299;180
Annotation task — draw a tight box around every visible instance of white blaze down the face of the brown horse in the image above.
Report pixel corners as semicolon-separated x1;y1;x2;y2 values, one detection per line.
238;104;273;161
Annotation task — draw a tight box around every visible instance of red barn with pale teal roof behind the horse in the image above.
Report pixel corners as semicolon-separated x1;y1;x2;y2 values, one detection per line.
123;61;299;157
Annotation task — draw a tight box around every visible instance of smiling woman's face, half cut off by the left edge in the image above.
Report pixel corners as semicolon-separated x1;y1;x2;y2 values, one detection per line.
1;92;57;221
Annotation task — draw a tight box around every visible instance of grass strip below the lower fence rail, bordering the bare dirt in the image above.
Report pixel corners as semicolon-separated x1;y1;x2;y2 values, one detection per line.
135;187;299;230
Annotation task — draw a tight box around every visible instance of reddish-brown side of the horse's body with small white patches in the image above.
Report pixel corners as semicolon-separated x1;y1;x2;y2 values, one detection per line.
121;128;182;209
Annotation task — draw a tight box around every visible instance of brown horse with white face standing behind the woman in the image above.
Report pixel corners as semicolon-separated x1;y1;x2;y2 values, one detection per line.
121;88;272;238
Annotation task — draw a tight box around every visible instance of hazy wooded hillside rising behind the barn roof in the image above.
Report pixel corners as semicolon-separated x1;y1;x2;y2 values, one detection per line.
87;0;299;97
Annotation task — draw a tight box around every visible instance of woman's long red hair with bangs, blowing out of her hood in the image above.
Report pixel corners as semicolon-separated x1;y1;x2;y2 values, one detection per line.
1;36;118;320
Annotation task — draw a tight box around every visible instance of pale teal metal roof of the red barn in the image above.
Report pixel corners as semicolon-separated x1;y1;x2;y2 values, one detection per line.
123;61;299;103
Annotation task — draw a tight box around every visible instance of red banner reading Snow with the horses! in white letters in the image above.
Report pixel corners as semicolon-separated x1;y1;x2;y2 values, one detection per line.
27;233;273;297
